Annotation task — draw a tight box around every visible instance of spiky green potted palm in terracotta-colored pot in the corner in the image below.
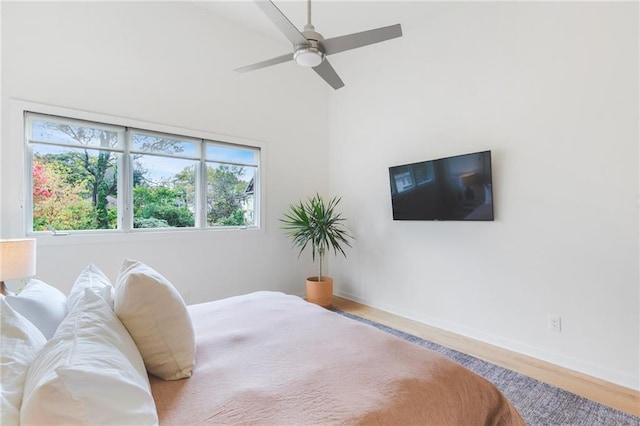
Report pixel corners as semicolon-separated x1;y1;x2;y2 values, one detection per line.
280;194;353;307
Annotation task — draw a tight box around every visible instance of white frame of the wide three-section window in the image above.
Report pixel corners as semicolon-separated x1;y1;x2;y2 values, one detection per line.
17;101;266;241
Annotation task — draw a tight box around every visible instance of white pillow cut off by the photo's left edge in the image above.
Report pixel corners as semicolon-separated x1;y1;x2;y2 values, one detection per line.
0;297;47;426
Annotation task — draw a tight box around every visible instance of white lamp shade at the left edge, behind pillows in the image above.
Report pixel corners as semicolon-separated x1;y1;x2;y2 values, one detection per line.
0;239;36;281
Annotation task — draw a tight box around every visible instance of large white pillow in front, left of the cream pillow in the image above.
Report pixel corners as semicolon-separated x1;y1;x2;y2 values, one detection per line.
20;289;158;425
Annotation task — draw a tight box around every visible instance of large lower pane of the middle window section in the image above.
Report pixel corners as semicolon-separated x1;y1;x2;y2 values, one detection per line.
133;155;197;228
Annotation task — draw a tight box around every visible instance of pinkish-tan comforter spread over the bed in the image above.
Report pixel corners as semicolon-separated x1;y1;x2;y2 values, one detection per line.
151;292;524;425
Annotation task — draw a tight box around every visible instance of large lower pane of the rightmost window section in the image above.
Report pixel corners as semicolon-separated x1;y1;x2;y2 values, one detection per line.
207;163;258;226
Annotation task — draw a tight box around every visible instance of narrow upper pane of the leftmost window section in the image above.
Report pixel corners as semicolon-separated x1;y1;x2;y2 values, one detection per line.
31;119;118;148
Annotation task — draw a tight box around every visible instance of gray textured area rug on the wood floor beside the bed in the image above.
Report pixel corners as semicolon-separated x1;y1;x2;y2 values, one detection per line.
333;309;640;426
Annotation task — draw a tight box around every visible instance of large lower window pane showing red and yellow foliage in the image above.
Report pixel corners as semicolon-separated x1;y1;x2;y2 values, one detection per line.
32;144;118;231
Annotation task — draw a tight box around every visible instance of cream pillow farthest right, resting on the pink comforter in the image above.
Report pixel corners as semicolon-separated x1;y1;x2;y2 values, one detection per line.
115;259;196;380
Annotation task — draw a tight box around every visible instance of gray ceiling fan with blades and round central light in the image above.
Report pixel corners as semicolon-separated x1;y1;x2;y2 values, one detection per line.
235;0;402;90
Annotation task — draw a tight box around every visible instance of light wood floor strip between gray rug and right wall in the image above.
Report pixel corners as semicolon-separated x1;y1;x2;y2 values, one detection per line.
333;296;640;417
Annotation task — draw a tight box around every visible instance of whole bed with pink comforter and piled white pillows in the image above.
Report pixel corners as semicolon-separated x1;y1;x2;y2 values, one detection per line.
2;265;524;425
